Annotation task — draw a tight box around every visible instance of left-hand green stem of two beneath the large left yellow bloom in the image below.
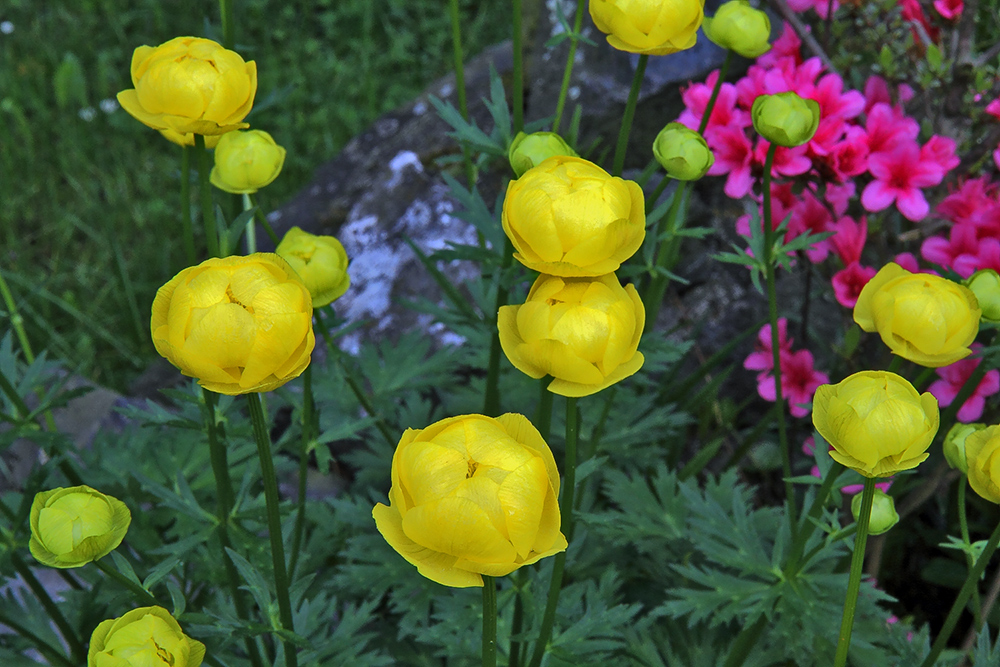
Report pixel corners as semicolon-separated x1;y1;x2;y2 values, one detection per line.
201;389;263;667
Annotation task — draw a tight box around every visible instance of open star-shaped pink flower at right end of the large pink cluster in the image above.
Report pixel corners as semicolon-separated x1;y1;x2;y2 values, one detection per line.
861;143;943;222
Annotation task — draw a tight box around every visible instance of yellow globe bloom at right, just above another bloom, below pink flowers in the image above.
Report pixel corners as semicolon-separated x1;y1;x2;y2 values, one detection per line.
854;262;982;368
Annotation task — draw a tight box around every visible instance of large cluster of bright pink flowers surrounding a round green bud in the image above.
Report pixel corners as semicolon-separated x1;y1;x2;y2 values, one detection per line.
679;22;960;308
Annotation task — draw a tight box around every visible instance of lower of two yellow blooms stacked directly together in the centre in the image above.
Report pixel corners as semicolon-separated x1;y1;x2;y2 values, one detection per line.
498;273;646;397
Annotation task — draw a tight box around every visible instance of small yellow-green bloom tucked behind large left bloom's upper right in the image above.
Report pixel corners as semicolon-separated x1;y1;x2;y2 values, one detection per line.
275;227;351;308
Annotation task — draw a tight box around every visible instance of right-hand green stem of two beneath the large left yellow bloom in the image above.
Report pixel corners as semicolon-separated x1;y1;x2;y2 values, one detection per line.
247;393;299;667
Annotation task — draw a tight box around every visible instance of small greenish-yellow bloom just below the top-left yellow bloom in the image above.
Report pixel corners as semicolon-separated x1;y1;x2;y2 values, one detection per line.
209;130;285;195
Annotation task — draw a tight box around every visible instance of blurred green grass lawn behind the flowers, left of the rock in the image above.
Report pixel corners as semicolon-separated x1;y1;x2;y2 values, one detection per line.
0;0;509;389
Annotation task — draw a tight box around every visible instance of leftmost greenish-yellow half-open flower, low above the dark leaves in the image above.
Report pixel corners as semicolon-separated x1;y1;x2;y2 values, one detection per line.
28;486;132;568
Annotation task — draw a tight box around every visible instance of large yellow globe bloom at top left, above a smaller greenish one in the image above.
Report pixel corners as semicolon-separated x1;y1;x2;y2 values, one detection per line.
118;37;257;135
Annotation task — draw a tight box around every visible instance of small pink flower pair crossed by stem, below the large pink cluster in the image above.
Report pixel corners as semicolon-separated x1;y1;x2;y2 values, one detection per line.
743;317;830;417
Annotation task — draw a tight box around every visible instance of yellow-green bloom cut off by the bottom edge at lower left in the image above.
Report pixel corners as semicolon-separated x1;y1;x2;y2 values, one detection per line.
87;607;205;667
